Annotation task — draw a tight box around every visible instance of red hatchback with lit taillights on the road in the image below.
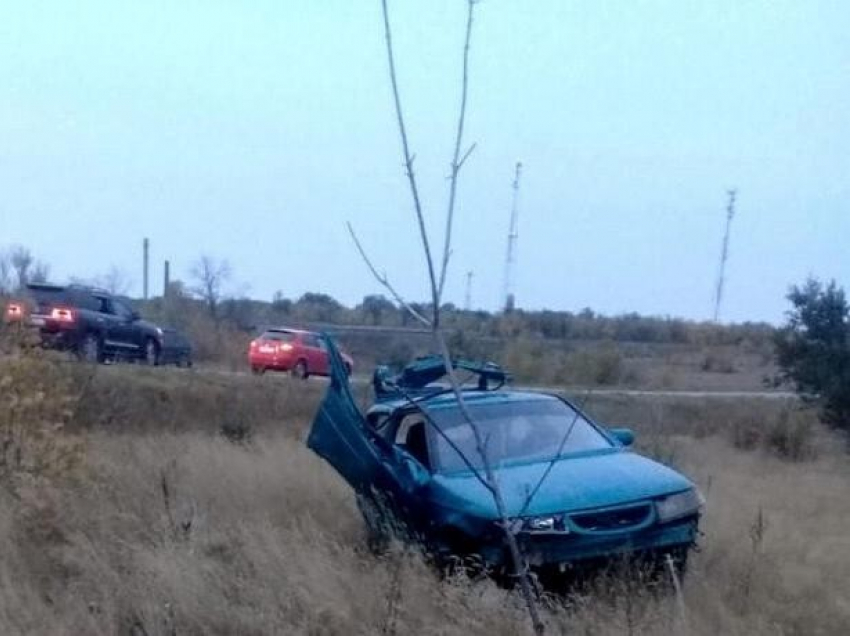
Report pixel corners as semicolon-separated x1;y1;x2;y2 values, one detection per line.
248;328;354;378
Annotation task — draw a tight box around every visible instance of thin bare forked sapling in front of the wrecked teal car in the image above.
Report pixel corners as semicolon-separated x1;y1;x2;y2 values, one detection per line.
349;0;544;634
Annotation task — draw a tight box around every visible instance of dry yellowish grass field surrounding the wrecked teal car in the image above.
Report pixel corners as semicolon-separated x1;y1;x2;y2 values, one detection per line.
0;356;850;636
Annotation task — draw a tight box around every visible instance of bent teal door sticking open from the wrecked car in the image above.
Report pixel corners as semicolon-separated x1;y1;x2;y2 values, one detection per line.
307;334;398;493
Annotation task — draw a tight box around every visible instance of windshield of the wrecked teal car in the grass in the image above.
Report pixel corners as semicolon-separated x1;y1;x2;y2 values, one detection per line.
429;398;613;473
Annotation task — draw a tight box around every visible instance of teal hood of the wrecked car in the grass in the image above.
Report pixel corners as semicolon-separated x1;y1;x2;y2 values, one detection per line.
432;450;693;519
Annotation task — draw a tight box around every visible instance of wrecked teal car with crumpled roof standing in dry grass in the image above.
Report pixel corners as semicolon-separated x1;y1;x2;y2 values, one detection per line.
308;341;703;573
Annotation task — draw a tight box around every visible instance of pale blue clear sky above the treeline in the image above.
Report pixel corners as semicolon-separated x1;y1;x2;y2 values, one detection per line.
0;0;850;321
